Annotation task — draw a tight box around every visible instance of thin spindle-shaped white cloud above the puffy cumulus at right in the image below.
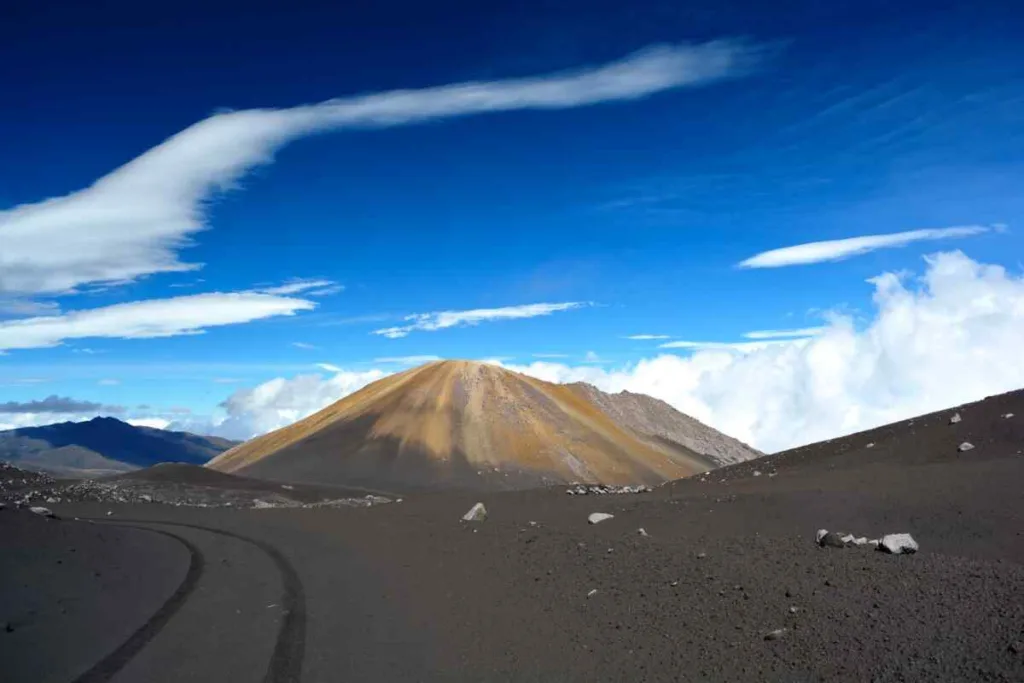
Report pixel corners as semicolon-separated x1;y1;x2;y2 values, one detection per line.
739;225;993;268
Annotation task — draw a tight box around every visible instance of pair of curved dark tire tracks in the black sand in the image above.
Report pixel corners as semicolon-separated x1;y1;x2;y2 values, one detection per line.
74;517;306;683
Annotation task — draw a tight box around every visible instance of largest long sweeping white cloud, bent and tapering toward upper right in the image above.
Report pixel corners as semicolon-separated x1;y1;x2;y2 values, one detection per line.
0;41;757;294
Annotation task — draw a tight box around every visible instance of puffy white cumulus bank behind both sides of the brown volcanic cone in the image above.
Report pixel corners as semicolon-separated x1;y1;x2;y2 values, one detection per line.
203;252;1024;452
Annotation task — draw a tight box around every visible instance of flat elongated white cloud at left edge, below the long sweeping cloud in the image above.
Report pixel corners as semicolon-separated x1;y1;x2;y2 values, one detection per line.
0;292;315;350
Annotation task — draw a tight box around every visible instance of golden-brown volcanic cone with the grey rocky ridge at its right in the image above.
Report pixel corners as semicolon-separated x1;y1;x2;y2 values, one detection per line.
209;360;758;490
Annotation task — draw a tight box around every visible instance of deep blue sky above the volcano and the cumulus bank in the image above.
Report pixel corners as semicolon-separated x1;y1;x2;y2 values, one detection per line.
0;1;1024;448
